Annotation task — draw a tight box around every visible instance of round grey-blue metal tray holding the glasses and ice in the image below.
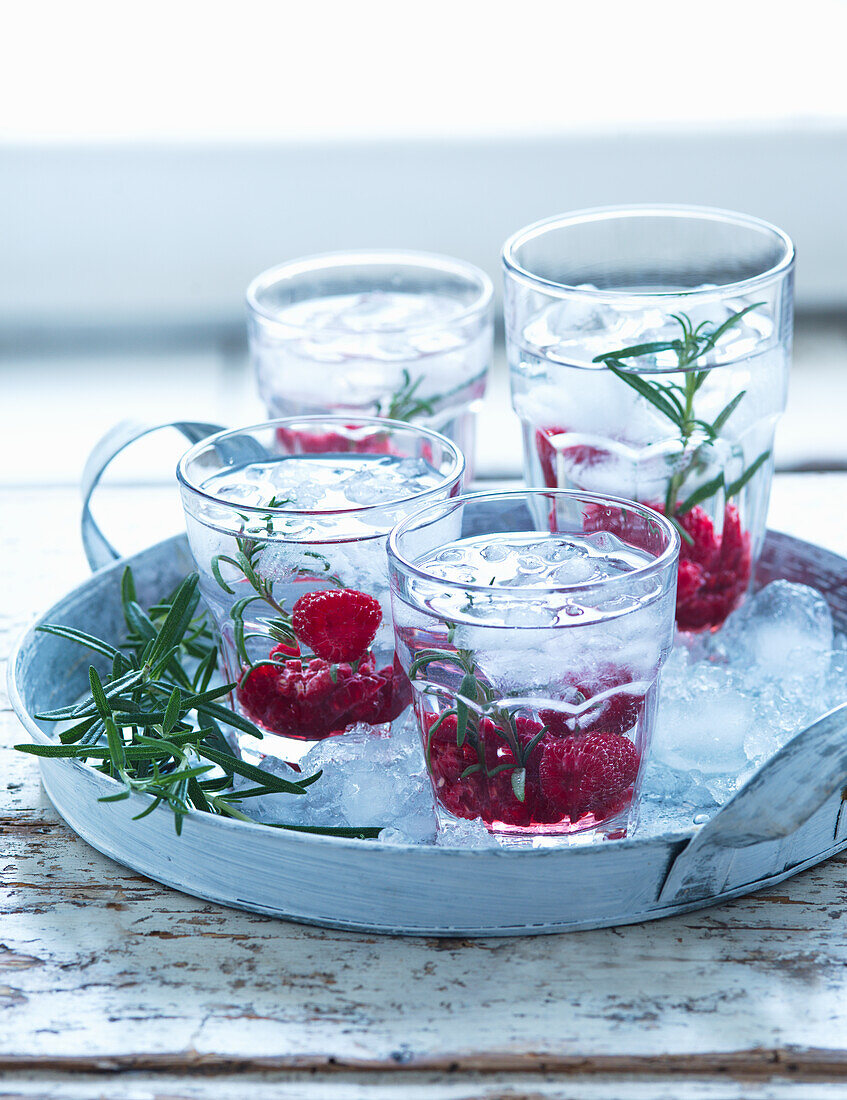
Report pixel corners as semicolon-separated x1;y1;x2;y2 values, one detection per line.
9;532;847;936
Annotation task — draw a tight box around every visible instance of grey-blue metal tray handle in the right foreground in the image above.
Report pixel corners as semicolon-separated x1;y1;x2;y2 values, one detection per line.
659;703;847;906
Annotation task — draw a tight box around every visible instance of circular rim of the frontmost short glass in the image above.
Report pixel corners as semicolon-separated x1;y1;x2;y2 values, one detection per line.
386;486;680;597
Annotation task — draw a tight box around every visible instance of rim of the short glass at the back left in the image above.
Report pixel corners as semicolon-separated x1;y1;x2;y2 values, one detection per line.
246;249;494;336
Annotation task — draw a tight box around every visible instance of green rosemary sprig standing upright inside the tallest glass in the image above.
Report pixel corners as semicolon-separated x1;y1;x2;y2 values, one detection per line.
593;301;770;519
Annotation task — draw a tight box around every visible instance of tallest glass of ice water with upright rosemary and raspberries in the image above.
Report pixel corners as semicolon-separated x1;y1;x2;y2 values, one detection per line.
503;207;794;631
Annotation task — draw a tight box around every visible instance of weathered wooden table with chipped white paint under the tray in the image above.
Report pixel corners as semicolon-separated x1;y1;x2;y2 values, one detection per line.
0;475;847;1100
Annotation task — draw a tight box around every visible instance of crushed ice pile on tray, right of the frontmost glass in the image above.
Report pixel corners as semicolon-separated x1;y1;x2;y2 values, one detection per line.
645;581;847;807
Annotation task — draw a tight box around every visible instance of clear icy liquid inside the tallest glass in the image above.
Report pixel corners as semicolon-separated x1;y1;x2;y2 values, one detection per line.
508;298;788;629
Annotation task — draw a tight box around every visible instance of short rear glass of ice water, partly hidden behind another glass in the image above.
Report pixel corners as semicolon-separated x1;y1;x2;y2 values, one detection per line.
248;252;493;479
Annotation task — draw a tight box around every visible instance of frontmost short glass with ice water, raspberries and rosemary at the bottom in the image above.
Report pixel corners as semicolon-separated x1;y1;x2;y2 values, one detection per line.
388;490;680;843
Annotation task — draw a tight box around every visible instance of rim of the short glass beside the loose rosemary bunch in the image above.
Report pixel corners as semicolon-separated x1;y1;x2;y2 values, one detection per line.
176;416;466;516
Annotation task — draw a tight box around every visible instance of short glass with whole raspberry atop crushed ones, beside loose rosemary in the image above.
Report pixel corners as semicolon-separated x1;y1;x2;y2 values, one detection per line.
177;417;464;760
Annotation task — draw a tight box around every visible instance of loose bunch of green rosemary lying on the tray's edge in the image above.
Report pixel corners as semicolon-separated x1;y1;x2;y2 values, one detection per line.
15;568;380;838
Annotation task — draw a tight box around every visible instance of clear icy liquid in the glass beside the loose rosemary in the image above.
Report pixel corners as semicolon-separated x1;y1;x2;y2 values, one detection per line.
188;454;444;759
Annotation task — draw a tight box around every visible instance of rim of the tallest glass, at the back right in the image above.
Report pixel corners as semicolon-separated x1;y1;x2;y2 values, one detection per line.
501;202;795;300
